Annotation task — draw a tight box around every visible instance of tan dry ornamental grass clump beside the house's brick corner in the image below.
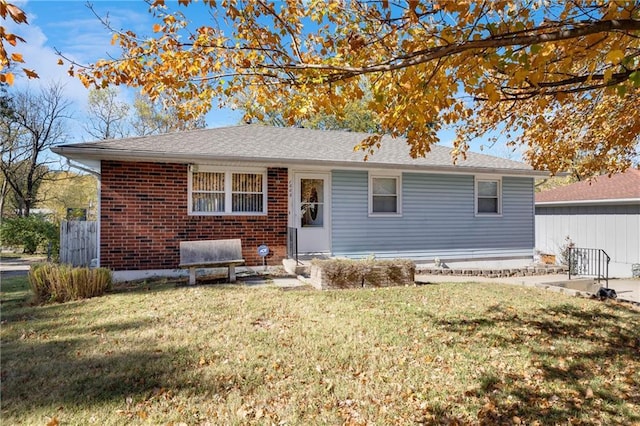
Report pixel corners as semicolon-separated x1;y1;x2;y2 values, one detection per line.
29;263;111;303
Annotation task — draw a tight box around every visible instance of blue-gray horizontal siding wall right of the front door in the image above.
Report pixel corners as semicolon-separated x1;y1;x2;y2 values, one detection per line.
332;170;535;257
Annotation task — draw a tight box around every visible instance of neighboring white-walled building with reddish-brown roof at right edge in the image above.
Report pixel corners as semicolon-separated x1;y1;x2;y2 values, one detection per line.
536;169;640;277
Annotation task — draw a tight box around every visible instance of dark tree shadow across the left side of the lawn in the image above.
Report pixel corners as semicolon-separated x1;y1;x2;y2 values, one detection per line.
0;321;228;420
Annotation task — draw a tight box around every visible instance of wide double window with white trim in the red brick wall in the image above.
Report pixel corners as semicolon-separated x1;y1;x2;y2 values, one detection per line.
189;167;267;215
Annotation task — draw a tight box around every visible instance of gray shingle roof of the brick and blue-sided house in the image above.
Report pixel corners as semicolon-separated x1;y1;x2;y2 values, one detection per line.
53;124;542;175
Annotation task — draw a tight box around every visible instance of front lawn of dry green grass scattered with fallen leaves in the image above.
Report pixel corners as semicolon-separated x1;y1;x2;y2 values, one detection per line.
1;278;640;425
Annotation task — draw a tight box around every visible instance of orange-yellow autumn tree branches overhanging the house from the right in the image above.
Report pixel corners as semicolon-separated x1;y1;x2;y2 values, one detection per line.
56;0;640;174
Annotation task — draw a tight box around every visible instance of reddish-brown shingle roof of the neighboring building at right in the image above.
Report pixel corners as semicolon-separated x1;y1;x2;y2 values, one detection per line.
536;169;640;203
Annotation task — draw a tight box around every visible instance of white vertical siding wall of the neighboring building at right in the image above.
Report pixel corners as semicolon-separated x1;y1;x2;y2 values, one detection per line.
536;204;640;277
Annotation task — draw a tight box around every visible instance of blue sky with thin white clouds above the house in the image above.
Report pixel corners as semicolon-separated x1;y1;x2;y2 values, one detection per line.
5;0;519;160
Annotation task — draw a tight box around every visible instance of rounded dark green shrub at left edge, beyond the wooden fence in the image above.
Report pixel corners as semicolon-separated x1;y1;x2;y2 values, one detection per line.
0;214;60;254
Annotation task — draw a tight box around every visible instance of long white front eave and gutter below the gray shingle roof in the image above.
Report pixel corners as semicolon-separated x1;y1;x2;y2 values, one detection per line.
52;146;549;177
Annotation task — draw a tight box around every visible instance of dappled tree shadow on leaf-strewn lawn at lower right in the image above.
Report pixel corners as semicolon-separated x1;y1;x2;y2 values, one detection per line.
427;304;640;425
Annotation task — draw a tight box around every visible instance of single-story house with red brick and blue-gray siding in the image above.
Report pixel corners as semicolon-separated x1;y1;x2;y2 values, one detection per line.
53;125;547;280
